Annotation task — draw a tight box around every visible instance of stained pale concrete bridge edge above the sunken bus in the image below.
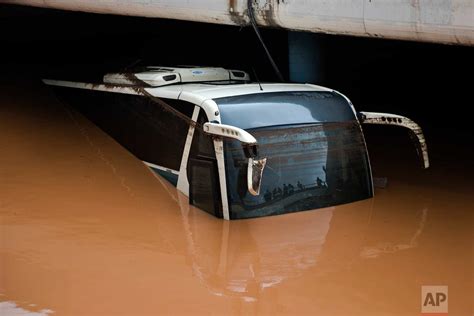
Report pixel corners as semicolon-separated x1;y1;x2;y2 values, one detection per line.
0;0;474;46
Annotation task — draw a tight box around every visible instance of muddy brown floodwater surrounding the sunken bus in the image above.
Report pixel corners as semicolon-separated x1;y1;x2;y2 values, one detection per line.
0;82;474;315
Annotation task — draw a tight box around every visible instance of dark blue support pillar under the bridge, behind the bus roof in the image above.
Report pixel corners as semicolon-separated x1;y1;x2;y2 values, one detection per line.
288;31;324;84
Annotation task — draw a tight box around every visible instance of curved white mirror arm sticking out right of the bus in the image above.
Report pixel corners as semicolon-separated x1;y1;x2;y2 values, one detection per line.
357;112;430;169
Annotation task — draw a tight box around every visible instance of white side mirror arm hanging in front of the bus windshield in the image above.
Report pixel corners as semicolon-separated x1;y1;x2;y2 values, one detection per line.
203;122;267;196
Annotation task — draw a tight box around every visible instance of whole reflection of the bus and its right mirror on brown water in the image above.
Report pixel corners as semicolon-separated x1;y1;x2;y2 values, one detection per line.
165;177;436;301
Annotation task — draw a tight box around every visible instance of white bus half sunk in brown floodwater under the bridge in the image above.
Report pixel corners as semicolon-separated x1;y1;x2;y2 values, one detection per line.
44;66;429;220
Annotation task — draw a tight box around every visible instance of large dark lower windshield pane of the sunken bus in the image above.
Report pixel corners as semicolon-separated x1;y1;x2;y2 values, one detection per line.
225;120;372;219
